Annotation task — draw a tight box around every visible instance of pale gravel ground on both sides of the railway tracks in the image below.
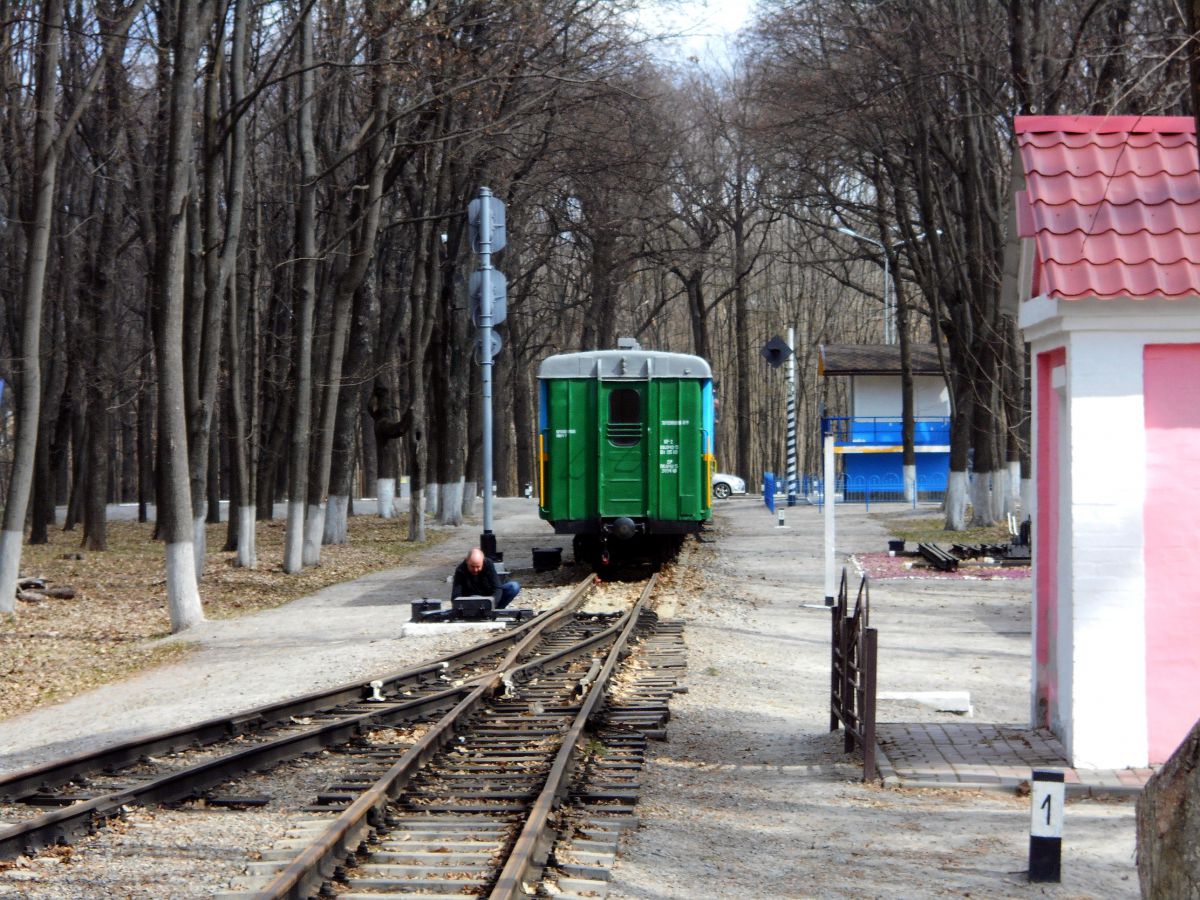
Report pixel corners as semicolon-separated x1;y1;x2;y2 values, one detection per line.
0;498;1138;899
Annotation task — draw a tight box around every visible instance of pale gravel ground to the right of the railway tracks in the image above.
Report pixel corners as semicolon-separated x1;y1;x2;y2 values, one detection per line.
610;499;1138;900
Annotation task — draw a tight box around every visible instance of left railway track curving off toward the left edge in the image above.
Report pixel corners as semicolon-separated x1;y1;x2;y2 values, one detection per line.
0;577;593;859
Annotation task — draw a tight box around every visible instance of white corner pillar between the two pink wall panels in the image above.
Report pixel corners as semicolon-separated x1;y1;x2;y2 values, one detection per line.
1060;331;1147;768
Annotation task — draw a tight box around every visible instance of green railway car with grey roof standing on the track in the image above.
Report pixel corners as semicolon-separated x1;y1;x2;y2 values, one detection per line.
538;347;713;566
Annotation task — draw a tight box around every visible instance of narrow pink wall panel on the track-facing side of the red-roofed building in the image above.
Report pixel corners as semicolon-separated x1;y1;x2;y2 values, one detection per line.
1033;347;1067;727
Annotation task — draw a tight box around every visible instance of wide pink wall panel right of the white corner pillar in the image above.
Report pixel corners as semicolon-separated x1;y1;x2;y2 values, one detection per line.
1144;343;1200;763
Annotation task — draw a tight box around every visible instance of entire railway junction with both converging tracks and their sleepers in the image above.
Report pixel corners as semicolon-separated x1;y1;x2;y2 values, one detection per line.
0;566;683;900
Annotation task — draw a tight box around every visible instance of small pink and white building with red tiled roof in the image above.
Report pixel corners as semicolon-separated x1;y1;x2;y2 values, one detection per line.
1014;116;1200;767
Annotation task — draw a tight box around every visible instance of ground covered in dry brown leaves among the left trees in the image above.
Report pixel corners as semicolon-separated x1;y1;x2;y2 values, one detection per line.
0;516;444;719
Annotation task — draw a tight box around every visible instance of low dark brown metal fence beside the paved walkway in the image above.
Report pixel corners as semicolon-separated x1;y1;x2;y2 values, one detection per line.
829;569;878;781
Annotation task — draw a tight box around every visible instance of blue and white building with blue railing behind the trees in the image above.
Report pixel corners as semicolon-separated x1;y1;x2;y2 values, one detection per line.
817;343;950;500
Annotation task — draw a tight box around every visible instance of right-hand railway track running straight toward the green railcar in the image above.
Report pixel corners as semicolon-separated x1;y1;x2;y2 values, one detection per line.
224;576;682;900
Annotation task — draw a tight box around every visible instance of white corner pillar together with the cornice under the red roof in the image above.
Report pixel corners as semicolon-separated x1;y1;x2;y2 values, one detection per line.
1021;298;1200;768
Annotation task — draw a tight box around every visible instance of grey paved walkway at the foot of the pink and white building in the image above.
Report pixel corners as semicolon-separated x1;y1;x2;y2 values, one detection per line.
875;722;1154;796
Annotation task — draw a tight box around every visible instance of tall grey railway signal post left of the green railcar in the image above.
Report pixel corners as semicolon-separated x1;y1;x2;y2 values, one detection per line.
467;187;508;560
